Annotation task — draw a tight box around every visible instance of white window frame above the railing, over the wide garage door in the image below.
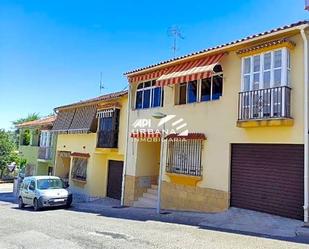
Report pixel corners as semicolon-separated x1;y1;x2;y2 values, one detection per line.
241;47;291;92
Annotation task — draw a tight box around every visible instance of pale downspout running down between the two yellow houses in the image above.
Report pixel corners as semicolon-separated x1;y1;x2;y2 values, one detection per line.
121;83;131;206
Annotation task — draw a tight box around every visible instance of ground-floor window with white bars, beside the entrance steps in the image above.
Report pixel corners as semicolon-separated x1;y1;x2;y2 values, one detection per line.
166;139;203;176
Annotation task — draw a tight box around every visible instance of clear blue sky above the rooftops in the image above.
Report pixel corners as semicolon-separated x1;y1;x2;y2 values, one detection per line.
0;0;309;129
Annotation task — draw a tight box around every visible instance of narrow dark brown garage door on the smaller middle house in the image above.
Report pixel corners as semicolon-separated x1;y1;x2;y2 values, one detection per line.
107;160;123;200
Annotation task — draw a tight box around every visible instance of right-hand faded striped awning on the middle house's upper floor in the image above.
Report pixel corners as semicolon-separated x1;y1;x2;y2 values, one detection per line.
68;105;97;133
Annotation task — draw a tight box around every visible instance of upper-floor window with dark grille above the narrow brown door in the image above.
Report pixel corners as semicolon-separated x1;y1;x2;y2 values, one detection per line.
97;108;120;148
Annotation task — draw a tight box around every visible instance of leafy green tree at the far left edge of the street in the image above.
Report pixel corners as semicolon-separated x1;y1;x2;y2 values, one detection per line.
0;129;19;179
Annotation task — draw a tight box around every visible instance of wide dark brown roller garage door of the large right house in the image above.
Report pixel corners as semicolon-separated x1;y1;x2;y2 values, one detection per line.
231;144;304;219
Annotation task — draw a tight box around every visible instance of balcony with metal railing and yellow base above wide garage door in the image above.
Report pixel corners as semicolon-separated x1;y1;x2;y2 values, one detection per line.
237;86;293;128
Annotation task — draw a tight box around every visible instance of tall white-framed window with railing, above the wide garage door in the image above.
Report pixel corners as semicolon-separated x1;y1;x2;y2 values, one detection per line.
239;48;291;120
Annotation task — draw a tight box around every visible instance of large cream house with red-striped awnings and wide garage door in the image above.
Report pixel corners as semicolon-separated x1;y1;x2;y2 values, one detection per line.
124;21;309;221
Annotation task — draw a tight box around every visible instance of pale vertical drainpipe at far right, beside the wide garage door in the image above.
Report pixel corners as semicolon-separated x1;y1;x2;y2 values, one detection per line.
300;25;309;222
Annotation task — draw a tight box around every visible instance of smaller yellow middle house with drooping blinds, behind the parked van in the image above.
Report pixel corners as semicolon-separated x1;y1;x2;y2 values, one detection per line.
52;91;127;200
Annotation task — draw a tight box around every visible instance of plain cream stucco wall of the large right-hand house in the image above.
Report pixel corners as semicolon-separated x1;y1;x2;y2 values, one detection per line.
126;32;304;195
